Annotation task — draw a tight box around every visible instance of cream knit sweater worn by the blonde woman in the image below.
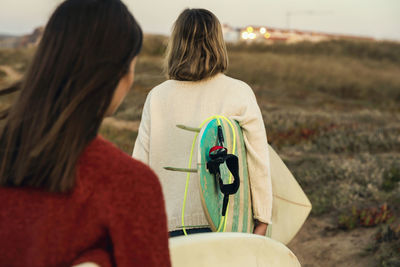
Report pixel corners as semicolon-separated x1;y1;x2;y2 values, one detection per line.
133;73;272;231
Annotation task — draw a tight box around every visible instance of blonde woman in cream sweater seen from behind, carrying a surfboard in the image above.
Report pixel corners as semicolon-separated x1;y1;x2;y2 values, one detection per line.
133;9;272;236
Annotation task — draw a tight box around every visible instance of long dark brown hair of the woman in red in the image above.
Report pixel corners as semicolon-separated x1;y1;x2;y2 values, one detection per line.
0;0;143;192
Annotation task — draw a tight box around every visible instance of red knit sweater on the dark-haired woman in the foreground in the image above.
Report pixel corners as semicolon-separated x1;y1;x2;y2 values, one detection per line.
0;137;170;267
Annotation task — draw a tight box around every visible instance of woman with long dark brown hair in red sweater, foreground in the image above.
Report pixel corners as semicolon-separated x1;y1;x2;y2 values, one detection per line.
0;0;170;266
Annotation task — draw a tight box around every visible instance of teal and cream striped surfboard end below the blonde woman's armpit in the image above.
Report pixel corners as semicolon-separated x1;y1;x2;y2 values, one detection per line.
198;119;254;233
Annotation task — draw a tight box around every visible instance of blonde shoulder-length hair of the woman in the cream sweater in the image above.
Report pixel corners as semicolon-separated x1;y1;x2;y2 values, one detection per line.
165;9;228;81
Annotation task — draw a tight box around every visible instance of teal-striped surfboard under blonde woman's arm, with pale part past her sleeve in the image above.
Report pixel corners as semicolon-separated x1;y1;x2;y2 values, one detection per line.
198;119;312;244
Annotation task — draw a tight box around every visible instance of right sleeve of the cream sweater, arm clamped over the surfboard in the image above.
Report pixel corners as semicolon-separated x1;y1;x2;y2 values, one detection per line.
232;85;272;224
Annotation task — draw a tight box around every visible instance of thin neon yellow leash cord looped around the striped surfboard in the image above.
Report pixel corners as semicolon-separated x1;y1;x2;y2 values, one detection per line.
182;115;236;236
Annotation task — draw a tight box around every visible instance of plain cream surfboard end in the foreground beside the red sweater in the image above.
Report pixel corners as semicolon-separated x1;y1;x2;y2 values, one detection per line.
169;233;301;267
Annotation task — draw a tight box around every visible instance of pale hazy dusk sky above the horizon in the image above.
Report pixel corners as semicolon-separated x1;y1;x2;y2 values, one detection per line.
0;0;400;41
